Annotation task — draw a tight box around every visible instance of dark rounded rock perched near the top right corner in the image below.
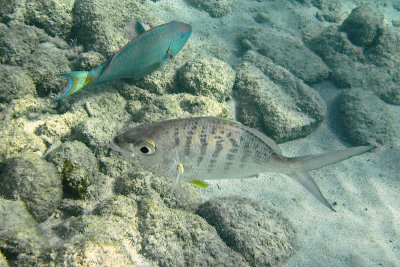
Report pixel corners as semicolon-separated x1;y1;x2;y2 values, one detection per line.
340;4;384;46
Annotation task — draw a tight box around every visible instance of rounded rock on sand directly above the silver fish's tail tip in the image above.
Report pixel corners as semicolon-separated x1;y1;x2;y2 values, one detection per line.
337;88;394;145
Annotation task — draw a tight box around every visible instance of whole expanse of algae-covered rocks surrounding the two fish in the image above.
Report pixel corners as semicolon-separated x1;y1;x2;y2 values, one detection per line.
0;0;400;266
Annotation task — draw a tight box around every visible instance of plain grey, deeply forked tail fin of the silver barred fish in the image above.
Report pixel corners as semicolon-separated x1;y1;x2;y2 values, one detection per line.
289;146;375;211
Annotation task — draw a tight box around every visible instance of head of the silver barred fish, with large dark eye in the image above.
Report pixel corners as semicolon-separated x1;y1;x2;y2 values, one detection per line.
110;124;171;174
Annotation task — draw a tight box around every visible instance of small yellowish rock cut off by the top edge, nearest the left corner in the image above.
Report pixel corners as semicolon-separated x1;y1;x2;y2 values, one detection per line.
24;0;74;38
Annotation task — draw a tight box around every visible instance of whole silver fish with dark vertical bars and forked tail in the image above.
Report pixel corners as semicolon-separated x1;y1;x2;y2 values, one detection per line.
111;117;374;211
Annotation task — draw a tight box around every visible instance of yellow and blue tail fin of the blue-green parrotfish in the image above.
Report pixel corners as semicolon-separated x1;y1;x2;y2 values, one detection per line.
52;71;93;101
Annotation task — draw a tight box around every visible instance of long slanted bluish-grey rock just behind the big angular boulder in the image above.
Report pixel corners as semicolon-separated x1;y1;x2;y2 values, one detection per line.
240;27;329;84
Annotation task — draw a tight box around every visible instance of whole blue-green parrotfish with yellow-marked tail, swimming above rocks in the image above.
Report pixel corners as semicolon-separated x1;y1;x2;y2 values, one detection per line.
53;21;192;101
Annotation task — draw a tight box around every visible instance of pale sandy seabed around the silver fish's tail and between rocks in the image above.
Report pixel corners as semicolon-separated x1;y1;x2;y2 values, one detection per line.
154;0;400;266
